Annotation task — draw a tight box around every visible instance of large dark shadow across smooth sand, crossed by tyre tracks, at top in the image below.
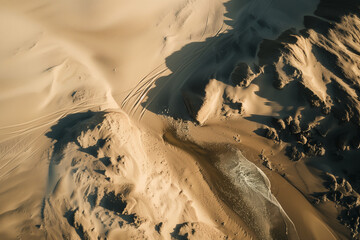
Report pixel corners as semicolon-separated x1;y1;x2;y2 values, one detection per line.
136;1;317;119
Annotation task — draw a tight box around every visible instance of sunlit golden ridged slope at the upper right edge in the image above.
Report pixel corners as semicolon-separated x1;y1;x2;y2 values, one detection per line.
259;11;359;124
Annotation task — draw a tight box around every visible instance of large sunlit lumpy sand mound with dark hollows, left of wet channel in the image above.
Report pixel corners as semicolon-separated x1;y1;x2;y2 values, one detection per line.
40;113;231;239
